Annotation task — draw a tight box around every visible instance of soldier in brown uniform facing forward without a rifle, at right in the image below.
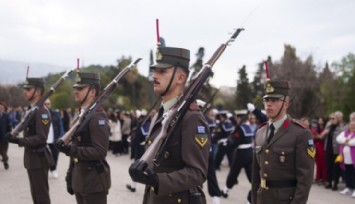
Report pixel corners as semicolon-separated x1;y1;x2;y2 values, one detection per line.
252;81;315;204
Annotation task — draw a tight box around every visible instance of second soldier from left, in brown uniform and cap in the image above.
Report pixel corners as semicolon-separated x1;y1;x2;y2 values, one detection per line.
56;73;111;204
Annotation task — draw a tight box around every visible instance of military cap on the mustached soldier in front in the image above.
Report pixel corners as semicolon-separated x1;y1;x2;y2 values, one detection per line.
151;47;190;71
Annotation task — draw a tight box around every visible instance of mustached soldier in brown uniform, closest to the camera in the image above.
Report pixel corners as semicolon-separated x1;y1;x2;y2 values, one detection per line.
129;47;210;204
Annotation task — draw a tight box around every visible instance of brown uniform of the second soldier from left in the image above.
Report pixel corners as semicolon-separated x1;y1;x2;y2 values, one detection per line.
68;109;111;204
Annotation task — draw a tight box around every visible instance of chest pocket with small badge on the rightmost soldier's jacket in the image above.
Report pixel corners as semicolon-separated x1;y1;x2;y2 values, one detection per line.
272;147;295;168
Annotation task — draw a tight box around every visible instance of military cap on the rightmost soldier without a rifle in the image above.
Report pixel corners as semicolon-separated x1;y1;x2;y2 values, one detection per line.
264;81;290;98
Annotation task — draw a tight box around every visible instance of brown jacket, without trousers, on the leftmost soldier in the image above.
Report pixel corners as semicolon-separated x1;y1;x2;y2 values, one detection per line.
19;106;54;169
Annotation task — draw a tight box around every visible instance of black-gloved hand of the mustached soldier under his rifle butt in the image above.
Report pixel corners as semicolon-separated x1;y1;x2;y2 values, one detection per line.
129;160;159;188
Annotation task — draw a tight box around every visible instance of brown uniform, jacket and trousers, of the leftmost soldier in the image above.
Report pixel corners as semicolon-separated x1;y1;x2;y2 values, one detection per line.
19;106;54;203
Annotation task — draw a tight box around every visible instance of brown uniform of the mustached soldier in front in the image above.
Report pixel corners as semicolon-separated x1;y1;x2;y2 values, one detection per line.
143;107;210;204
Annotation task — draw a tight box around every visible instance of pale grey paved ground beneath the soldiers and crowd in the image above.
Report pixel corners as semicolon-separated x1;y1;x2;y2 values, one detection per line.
0;144;355;204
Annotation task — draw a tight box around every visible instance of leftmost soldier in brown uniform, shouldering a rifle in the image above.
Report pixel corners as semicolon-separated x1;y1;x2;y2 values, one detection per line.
9;78;54;204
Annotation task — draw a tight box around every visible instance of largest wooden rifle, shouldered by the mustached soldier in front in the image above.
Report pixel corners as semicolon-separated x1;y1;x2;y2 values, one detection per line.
140;28;244;167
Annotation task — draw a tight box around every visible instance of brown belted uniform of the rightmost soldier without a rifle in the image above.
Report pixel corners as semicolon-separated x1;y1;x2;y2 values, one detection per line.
252;117;315;204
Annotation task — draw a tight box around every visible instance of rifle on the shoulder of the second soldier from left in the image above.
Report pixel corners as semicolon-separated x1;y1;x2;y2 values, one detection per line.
57;58;141;144
